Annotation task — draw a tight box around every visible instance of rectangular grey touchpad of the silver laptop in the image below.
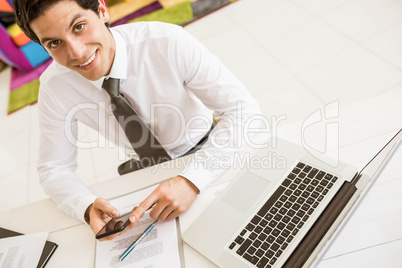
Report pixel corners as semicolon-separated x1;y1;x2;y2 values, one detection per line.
221;172;270;213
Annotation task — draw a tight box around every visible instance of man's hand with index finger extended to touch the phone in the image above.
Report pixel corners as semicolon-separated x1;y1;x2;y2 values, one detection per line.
128;176;199;228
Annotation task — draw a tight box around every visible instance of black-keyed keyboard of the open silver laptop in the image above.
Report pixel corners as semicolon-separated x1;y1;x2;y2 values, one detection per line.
229;162;338;268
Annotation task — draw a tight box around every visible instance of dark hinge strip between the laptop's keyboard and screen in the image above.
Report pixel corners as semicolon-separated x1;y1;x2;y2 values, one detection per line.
283;181;357;268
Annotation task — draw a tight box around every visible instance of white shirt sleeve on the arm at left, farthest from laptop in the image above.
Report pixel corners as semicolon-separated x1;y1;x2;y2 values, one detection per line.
38;79;96;222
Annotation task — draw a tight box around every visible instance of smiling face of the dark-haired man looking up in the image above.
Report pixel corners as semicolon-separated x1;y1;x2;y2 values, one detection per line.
30;1;116;81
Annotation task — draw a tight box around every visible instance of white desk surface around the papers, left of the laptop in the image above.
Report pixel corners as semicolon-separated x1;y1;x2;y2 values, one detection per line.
0;155;228;268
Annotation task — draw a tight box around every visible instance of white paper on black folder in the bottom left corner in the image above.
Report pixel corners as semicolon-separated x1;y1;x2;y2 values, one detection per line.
0;232;49;268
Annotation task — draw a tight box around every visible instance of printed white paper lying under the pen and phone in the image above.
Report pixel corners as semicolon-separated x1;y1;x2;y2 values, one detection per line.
96;187;182;268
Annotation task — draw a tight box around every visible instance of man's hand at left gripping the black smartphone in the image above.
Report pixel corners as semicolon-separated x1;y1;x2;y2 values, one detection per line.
88;198;120;240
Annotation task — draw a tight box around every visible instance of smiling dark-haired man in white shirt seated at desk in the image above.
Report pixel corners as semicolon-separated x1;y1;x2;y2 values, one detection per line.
14;0;259;238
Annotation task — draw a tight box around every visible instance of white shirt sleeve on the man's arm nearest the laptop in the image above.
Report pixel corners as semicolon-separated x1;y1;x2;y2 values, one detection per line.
171;25;263;191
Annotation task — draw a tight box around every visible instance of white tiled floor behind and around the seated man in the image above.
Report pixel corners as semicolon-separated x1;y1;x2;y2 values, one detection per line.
0;0;402;267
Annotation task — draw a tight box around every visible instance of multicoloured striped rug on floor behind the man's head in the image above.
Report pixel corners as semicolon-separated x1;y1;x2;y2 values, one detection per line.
8;0;237;114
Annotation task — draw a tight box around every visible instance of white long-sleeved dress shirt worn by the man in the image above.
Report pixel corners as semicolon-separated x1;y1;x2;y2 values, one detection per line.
38;22;260;220
